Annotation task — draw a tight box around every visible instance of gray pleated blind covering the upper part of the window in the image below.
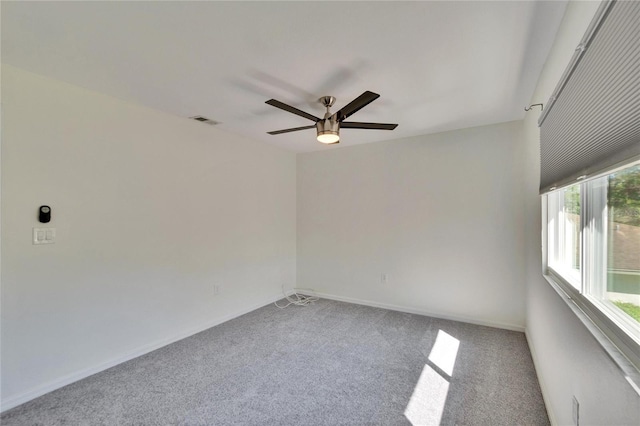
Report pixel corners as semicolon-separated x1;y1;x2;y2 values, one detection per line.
538;1;640;193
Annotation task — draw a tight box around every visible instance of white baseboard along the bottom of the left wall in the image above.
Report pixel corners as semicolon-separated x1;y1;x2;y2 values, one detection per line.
0;293;283;412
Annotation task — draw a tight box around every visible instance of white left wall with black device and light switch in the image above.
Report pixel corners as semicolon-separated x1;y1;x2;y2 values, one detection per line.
1;66;296;409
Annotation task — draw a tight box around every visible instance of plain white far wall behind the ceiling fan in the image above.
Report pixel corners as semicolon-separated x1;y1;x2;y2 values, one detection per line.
297;122;525;330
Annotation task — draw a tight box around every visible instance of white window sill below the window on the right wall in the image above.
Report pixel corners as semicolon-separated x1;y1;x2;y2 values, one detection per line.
543;274;640;396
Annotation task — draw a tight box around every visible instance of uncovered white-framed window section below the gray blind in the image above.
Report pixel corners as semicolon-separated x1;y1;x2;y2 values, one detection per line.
545;161;640;369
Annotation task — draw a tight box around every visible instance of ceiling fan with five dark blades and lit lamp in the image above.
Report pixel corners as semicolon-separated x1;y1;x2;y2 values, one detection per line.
266;90;398;144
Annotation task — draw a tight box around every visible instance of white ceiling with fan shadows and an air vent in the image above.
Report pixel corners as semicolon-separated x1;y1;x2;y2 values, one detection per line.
1;1;566;152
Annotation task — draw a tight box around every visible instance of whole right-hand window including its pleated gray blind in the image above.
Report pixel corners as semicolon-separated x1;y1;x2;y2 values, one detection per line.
538;1;640;386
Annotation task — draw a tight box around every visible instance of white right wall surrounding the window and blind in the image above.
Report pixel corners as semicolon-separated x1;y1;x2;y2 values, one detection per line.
523;2;640;425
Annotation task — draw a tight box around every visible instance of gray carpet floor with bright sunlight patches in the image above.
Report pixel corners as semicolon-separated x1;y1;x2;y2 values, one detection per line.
1;300;549;426
